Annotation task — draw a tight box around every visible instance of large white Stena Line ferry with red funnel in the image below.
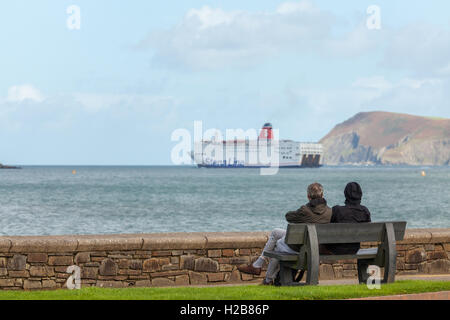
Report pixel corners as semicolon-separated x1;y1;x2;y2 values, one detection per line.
191;123;323;168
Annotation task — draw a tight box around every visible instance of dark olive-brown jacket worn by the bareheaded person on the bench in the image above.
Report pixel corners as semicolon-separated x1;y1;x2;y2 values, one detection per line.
286;198;331;251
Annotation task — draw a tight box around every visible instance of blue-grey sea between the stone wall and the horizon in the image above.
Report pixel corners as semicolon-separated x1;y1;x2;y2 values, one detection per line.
0;166;450;235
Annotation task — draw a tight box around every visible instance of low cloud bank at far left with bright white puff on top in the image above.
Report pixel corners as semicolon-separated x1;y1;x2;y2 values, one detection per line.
0;86;180;132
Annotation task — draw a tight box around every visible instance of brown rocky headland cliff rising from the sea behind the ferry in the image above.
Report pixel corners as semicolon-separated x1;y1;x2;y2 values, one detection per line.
320;112;450;165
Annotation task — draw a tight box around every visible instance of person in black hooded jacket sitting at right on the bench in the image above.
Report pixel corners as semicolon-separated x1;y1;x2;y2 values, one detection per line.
326;182;371;254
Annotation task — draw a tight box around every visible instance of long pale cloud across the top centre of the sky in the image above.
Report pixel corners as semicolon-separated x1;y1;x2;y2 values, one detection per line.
138;1;334;69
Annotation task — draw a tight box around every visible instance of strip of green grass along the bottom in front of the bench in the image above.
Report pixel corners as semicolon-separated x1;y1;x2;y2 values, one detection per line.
0;280;450;300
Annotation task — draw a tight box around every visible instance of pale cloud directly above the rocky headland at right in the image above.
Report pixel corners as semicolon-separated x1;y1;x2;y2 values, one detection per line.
277;75;450;137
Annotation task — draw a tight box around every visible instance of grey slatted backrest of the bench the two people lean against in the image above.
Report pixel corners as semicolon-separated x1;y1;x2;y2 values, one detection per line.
285;221;406;244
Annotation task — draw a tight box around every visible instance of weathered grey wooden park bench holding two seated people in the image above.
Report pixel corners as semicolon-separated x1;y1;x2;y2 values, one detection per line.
264;221;406;285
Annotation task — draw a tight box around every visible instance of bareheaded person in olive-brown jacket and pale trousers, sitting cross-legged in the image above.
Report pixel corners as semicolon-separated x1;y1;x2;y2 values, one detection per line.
238;182;331;285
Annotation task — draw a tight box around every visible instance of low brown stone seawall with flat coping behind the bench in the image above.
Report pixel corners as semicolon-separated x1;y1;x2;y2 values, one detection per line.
0;229;450;290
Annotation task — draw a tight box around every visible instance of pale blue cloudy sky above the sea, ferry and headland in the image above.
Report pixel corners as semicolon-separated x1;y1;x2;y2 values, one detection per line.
0;0;450;165
